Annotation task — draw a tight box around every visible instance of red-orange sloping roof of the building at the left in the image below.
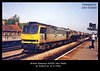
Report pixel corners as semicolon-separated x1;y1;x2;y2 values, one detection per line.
2;24;22;32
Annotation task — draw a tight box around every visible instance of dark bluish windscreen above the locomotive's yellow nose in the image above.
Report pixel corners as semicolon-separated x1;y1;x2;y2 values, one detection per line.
22;25;39;34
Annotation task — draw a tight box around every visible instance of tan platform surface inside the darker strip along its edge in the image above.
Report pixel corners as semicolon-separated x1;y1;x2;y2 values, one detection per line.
68;39;98;60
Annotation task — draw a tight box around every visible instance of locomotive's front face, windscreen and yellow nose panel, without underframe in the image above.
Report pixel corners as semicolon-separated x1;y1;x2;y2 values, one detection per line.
21;25;39;43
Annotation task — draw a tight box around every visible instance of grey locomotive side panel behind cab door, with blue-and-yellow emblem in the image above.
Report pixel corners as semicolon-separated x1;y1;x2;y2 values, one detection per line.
46;26;66;42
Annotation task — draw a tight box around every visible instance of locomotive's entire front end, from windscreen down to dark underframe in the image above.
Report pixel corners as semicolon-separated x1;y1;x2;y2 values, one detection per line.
21;24;45;53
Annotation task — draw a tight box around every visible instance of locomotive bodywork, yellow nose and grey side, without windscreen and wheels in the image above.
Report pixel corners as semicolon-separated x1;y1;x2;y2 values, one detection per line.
21;24;70;44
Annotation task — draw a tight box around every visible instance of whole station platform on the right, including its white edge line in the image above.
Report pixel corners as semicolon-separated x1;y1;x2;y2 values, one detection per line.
57;39;98;60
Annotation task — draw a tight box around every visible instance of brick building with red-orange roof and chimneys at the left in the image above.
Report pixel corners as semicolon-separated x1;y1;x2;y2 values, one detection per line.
2;21;22;39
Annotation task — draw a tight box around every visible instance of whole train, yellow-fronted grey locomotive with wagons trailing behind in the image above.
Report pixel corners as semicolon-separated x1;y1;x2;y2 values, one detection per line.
21;22;88;53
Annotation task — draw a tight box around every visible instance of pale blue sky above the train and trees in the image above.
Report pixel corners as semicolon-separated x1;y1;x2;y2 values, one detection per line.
2;2;98;33
